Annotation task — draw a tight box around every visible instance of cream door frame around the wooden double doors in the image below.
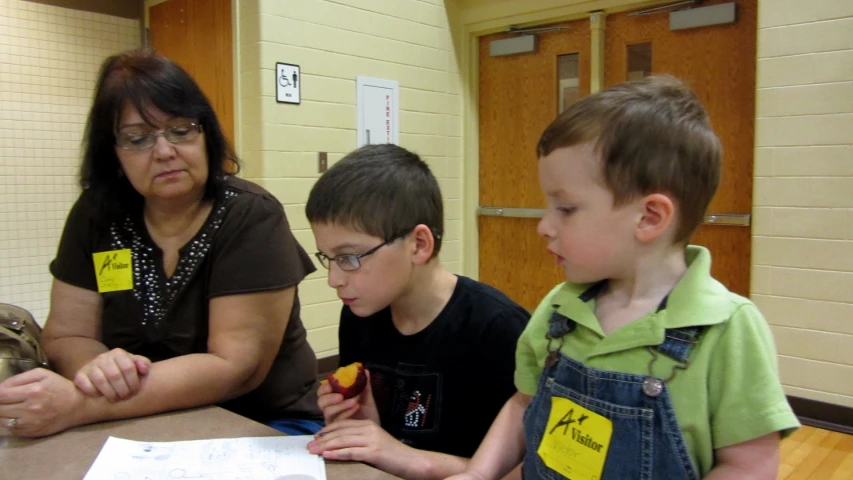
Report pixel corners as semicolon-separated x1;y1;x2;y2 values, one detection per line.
456;0;684;280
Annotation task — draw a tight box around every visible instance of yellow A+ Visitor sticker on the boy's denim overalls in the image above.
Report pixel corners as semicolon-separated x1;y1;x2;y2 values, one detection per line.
536;397;613;480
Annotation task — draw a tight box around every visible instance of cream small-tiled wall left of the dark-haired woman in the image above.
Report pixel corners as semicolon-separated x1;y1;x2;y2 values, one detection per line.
0;0;140;323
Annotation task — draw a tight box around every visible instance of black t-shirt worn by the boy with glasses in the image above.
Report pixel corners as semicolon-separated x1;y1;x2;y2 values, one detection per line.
338;277;530;458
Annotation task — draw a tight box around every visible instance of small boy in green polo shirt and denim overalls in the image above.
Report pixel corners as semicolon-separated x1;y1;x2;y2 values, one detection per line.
454;77;799;480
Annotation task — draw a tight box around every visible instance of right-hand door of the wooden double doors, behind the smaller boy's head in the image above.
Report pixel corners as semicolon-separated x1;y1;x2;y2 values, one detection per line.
605;0;757;296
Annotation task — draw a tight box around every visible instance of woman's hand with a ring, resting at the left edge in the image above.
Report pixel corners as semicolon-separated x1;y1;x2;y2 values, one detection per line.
0;368;86;437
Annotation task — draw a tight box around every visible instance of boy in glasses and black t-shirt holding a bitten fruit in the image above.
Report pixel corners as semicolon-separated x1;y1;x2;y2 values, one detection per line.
306;145;529;479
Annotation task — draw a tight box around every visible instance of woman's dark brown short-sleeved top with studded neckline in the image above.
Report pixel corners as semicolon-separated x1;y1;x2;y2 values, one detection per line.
50;177;322;421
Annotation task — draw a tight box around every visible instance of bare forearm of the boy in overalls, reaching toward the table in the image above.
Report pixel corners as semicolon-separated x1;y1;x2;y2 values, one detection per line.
448;392;532;480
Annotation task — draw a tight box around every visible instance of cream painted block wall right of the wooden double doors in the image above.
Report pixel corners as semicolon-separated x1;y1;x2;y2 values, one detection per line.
752;0;853;407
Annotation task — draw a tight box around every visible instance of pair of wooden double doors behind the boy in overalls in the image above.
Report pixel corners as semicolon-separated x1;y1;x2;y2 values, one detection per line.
477;0;757;309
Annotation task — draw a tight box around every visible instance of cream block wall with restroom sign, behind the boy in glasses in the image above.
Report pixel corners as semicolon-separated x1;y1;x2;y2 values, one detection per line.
239;0;462;357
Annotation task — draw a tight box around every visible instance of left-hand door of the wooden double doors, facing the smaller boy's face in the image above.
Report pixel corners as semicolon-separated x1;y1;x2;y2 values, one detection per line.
477;20;590;311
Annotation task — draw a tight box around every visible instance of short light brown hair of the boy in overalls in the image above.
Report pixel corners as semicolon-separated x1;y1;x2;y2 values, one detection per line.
536;76;722;243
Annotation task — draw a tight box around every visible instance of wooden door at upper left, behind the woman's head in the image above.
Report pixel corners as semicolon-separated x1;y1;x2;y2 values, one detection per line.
148;0;234;149
